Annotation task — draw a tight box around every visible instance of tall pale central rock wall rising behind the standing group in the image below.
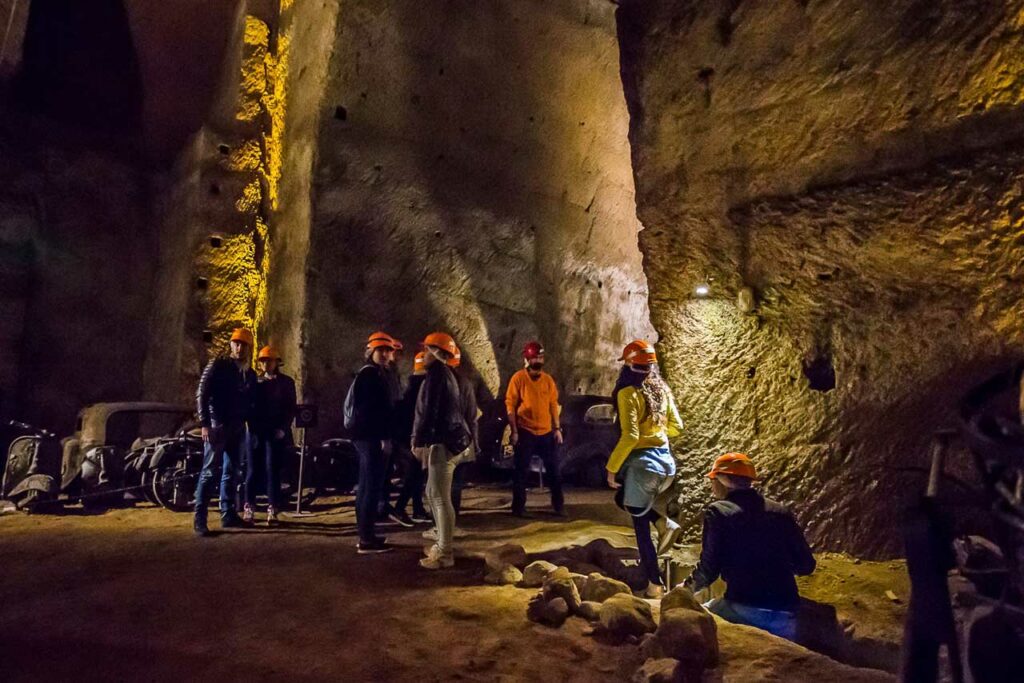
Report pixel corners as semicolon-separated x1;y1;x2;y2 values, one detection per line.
299;0;650;432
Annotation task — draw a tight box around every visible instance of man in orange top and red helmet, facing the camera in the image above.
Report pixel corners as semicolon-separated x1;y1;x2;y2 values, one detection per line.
505;341;564;517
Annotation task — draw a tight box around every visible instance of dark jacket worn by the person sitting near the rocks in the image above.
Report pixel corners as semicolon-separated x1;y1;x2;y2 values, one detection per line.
688;488;815;610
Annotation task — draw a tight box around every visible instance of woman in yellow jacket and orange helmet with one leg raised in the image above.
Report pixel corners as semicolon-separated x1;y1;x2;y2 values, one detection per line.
606;339;682;598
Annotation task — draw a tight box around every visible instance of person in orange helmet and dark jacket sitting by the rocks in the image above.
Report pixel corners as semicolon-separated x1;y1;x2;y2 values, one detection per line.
684;453;815;640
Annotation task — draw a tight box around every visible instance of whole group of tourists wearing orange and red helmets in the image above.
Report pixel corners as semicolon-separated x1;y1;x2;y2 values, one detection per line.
195;329;815;638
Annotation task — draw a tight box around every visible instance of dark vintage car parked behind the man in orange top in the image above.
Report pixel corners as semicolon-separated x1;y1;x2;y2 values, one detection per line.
479;394;618;487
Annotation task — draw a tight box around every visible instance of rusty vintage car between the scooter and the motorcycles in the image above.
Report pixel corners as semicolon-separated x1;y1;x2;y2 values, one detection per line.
60;401;195;507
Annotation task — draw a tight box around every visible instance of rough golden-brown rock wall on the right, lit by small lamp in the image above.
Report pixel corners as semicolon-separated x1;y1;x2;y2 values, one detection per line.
618;0;1024;555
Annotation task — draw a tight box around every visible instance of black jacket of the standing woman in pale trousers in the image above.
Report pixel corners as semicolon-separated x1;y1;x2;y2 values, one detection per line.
413;362;469;455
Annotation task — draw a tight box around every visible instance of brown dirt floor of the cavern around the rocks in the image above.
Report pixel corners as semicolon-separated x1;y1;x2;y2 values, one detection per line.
0;488;899;683
